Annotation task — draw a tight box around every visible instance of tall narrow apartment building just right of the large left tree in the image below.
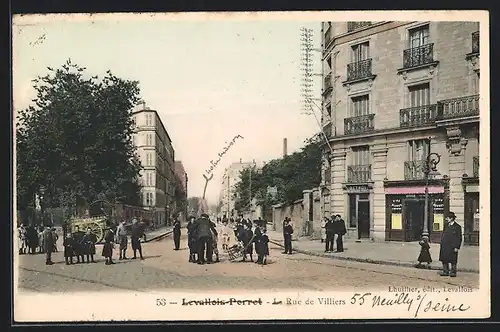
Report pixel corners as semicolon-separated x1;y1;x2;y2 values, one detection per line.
132;102;175;225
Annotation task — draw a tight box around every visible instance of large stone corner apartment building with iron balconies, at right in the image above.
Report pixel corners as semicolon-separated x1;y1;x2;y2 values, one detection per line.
321;21;480;244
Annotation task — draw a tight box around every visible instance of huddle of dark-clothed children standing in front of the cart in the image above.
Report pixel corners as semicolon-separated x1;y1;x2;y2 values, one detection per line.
63;226;97;265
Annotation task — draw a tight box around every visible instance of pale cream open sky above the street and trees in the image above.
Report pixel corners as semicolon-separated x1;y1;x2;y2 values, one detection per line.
12;15;321;203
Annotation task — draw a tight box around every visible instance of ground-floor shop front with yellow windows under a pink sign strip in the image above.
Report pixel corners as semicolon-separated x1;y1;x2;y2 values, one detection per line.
385;185;446;243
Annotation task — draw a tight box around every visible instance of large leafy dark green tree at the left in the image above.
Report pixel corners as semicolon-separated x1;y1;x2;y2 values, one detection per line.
16;60;141;213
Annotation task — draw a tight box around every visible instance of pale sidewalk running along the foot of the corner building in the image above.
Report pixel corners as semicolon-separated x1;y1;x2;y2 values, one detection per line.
268;231;479;273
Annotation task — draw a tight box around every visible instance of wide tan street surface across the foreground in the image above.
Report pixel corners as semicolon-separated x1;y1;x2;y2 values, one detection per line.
18;231;479;292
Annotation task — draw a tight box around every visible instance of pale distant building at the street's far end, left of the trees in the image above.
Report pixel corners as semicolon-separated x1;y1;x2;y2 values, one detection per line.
219;159;256;218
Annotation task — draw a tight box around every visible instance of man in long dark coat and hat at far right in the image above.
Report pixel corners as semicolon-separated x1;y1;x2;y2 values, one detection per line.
439;212;462;277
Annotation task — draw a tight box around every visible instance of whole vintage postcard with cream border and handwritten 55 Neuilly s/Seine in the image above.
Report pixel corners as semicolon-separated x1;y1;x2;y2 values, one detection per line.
12;11;491;323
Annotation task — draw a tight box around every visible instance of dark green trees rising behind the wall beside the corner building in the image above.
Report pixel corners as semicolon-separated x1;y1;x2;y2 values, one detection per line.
233;135;322;214
